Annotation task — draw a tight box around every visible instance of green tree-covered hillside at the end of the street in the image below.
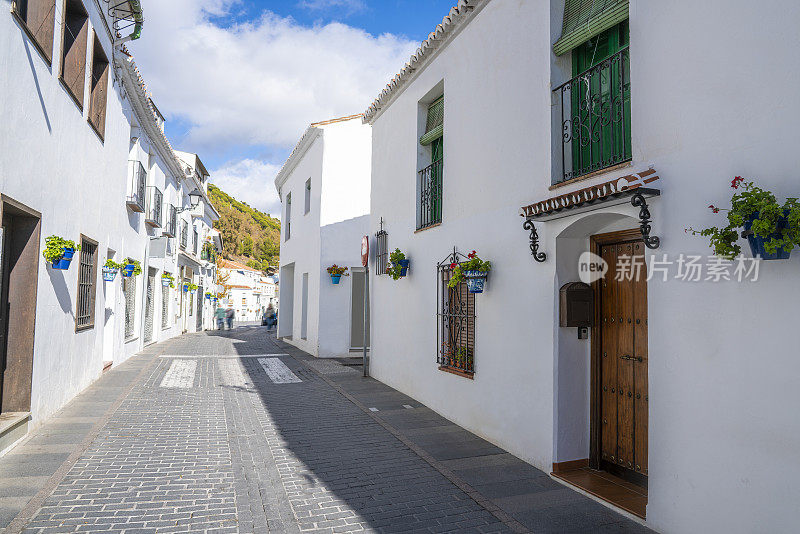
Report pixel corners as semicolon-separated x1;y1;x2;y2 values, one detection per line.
208;184;281;272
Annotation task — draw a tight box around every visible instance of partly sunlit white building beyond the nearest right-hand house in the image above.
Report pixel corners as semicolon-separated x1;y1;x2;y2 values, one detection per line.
275;115;371;357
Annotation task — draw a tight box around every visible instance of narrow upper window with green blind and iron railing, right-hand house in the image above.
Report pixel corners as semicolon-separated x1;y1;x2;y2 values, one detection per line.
417;96;444;230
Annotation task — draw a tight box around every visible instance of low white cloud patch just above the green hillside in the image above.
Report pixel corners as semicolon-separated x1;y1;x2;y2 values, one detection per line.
210;159;281;218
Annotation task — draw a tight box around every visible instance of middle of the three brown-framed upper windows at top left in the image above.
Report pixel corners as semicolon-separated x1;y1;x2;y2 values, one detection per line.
61;0;89;109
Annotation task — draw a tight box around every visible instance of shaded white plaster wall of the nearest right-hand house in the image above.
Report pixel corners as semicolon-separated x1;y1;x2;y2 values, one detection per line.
371;0;800;533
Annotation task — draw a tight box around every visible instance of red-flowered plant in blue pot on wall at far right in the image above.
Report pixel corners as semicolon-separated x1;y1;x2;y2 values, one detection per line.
686;176;800;260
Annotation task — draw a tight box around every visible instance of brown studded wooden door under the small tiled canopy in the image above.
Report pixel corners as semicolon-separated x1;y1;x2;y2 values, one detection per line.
594;233;649;485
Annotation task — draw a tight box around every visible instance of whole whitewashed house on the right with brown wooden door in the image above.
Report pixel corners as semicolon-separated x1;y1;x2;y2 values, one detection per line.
366;0;800;533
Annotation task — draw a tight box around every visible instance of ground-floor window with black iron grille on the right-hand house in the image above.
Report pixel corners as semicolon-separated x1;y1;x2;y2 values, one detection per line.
436;252;475;378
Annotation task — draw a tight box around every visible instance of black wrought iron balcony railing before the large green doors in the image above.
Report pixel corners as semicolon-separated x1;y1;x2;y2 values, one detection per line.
553;48;631;183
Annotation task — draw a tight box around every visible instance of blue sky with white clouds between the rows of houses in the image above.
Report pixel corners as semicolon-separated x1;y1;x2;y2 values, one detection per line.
131;0;456;218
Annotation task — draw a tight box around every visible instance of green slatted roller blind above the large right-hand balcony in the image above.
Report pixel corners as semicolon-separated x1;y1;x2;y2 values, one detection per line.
553;0;628;56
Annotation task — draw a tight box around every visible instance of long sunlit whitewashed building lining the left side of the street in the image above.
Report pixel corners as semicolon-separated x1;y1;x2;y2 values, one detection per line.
0;0;219;453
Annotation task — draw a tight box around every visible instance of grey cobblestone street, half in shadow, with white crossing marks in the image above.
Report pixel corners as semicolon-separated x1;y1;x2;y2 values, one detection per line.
0;326;646;533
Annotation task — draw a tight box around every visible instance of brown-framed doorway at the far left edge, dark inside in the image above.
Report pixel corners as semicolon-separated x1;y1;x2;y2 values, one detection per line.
0;196;41;414
